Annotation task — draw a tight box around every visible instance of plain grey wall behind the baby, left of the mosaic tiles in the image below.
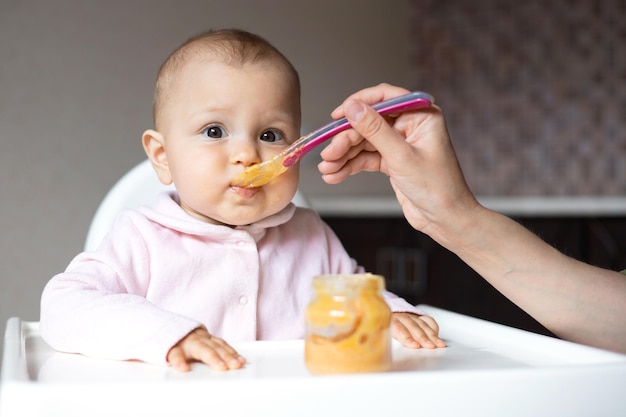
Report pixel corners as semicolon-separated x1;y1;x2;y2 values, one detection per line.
0;0;410;360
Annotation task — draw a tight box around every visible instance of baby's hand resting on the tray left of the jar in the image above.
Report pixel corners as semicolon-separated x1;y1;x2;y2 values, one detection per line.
167;327;246;372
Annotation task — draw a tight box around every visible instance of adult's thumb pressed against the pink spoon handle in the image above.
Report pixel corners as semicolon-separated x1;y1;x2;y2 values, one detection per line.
343;99;407;158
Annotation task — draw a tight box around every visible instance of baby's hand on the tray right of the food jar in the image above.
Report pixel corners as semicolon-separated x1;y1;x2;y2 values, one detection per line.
391;313;446;349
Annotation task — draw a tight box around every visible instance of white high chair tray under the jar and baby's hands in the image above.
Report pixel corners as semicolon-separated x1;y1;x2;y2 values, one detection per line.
0;306;626;417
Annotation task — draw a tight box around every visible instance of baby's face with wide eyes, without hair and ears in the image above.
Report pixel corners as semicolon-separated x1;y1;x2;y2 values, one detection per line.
160;62;300;225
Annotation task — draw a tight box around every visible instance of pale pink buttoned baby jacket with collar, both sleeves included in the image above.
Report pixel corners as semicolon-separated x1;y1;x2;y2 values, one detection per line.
40;193;419;364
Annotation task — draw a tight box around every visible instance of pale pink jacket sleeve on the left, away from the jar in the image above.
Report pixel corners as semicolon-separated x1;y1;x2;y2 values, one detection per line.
40;213;200;364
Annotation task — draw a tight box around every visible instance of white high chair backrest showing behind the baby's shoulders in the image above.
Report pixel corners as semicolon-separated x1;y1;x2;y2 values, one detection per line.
85;159;309;251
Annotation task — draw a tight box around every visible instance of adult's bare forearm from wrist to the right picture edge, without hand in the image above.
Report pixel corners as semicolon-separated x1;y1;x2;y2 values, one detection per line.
431;206;626;352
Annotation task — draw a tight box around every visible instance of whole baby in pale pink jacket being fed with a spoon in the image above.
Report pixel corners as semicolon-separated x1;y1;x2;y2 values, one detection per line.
40;30;445;371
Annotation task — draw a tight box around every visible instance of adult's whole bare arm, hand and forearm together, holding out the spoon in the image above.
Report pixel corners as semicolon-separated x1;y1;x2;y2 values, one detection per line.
318;84;626;353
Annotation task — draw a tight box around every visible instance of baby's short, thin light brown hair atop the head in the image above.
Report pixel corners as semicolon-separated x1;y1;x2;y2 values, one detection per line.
153;29;300;130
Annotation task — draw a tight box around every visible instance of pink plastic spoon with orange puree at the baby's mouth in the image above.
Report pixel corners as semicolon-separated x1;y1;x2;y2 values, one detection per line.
232;91;435;188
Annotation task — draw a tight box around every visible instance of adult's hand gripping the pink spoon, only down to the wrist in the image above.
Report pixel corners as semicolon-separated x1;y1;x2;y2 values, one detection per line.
318;84;478;234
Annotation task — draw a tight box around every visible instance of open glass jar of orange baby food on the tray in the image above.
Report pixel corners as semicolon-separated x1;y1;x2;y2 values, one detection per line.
304;274;391;374
